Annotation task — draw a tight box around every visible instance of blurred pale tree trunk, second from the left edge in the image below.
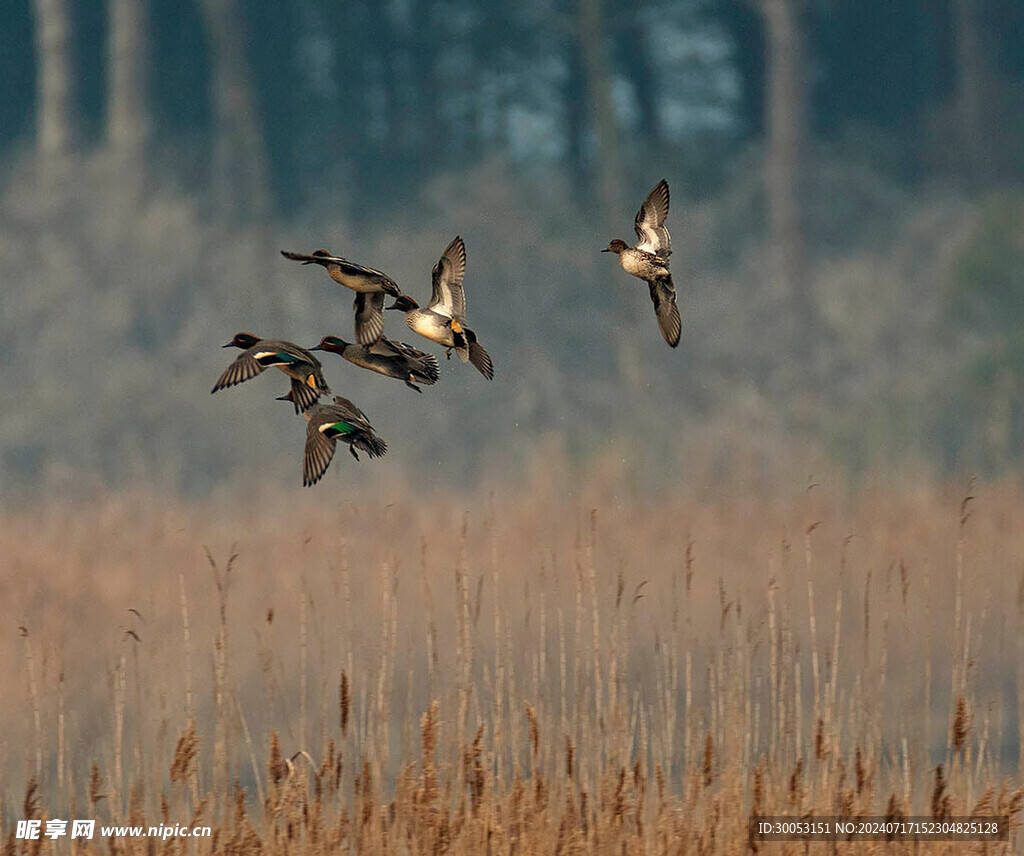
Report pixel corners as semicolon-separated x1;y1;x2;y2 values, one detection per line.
106;0;150;168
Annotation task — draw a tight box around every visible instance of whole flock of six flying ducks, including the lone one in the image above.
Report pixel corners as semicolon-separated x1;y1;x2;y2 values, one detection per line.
213;179;682;486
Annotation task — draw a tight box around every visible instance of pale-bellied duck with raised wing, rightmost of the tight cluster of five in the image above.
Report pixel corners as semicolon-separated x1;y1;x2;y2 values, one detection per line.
387;236;495;381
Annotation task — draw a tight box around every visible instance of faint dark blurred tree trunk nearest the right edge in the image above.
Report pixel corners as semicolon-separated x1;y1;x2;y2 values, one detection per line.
953;0;989;188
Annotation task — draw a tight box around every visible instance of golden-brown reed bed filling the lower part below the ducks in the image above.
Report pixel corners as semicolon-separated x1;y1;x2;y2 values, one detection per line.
0;467;1024;856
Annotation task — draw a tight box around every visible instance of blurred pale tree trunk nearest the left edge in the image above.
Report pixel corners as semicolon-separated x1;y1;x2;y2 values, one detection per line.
32;0;78;169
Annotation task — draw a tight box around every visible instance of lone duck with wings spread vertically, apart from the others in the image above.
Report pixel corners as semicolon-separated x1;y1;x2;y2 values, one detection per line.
601;178;683;348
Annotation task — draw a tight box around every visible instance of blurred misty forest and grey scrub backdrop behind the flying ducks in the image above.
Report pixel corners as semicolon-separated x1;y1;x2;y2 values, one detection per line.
0;0;1024;496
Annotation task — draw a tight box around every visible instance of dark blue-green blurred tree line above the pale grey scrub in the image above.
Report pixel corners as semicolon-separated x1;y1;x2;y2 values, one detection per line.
0;0;1024;212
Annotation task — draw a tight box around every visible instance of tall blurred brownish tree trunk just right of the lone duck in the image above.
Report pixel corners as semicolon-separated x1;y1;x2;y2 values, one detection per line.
761;0;818;359
